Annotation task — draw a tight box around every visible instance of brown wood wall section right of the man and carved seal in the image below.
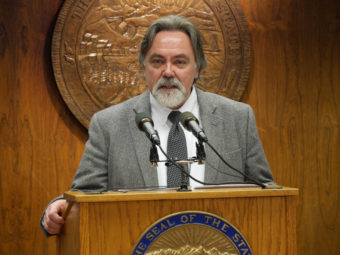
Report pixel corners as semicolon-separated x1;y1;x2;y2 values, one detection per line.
239;0;340;254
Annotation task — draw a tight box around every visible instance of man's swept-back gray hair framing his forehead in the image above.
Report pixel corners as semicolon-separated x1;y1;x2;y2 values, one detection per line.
138;15;207;72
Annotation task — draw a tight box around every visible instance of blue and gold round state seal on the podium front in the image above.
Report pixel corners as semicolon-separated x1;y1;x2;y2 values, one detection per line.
132;211;252;255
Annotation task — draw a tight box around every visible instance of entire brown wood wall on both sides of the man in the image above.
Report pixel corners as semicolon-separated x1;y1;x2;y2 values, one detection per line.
0;0;340;255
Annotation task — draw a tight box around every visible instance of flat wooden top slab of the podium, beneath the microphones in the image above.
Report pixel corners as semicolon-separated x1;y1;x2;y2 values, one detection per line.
64;187;299;202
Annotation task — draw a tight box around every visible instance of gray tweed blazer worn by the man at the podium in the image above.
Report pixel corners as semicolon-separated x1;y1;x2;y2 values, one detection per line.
72;89;274;191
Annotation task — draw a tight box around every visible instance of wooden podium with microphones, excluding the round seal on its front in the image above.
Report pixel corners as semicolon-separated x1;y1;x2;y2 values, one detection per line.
57;187;298;255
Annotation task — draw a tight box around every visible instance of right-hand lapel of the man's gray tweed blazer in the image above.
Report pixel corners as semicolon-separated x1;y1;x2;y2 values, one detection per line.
196;88;225;183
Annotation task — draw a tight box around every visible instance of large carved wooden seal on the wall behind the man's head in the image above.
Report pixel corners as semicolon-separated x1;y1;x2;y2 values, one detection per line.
52;0;251;127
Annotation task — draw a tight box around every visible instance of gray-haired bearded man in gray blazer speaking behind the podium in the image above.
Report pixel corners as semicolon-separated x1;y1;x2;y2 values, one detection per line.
41;16;274;236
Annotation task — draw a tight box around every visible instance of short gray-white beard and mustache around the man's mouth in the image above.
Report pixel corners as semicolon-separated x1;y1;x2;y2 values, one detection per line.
152;78;187;108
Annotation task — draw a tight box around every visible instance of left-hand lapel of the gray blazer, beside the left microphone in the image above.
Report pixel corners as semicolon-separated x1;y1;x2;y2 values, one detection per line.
128;90;158;187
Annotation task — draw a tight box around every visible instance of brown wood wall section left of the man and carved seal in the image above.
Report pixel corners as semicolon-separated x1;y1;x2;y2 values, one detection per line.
0;0;86;254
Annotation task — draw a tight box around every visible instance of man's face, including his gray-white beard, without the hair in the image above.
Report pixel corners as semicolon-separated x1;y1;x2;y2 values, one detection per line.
145;31;199;109
